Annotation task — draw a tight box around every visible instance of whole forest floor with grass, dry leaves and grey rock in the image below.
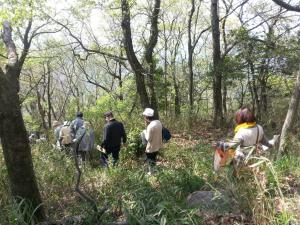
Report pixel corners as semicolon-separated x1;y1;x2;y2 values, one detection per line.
0;125;300;225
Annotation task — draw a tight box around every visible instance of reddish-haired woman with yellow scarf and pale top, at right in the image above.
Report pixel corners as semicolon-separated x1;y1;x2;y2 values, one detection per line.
214;107;279;170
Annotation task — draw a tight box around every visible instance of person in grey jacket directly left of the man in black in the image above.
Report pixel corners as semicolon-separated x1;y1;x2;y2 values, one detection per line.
73;121;95;162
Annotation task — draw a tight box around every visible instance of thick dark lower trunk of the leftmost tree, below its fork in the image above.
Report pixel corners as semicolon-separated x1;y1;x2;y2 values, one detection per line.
0;79;45;219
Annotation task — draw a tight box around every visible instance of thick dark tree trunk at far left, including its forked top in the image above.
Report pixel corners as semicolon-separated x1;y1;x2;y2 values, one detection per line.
0;22;46;221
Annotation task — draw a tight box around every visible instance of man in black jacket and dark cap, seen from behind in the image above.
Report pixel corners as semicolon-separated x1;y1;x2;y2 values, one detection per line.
101;111;127;167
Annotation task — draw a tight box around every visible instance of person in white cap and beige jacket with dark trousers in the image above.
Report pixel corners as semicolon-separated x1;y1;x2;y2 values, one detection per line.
143;108;163;175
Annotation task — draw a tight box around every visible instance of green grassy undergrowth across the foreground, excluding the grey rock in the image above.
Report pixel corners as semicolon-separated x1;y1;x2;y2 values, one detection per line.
0;134;300;225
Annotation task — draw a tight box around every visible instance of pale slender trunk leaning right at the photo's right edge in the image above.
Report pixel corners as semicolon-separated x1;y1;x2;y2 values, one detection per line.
277;71;300;157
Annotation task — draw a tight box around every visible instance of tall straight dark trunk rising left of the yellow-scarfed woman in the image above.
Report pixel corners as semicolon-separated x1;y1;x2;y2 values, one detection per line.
211;0;223;127
